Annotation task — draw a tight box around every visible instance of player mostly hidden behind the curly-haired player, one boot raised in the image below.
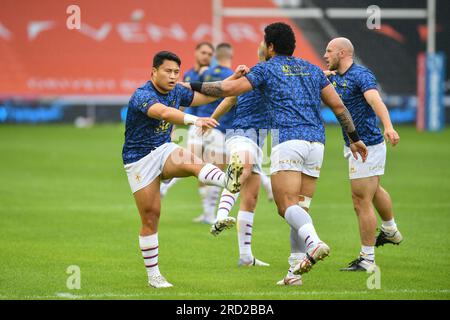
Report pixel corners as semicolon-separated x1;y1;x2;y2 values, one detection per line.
205;43;272;266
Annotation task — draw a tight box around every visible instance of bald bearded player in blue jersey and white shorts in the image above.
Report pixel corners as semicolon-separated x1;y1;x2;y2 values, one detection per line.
324;38;403;271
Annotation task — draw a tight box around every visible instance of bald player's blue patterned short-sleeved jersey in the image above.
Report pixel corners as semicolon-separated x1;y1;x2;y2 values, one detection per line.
330;63;384;146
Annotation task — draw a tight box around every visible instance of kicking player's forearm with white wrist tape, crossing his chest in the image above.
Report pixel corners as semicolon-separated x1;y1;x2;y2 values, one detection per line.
147;103;219;129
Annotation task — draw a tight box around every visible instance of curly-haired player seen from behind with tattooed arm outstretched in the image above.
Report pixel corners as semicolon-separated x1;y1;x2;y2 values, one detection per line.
185;22;367;285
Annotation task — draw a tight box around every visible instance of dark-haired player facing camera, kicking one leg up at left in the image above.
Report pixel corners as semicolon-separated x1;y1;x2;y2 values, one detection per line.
122;51;243;288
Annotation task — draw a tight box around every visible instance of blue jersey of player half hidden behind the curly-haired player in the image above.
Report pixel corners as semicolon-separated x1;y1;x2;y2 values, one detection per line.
227;89;270;147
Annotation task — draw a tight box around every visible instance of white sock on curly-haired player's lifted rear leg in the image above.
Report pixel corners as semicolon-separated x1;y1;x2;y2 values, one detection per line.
284;205;320;250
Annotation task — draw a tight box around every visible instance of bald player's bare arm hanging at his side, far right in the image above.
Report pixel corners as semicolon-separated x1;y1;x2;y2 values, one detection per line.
364;89;400;146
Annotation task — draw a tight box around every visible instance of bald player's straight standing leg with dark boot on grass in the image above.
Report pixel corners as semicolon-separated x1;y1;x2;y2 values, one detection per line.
341;176;379;271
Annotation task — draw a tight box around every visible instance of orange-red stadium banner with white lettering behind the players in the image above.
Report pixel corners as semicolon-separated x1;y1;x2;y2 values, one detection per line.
0;0;323;98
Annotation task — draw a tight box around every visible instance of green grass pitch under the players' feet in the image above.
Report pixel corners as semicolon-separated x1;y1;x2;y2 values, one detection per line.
0;125;450;299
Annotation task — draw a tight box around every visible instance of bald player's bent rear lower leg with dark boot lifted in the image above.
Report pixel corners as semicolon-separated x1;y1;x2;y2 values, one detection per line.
373;184;403;247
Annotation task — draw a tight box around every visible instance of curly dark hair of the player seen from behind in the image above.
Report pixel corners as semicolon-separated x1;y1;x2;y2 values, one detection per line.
264;22;295;56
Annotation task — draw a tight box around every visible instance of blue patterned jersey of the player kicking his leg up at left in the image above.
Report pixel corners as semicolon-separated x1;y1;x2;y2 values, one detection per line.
122;81;194;164
